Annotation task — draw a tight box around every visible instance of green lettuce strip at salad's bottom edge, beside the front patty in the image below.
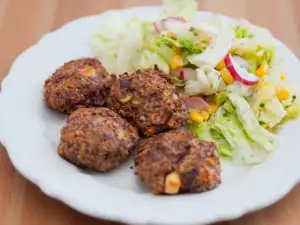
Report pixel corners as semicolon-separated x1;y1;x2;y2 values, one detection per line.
189;101;269;165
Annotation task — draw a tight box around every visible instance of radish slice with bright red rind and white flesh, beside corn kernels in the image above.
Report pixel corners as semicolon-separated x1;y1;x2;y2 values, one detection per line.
224;54;259;85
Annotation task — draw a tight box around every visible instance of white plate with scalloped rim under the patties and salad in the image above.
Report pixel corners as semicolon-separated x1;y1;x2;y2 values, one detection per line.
0;7;300;224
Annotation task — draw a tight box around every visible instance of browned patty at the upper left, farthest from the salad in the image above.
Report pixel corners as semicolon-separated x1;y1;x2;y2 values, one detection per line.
44;58;113;113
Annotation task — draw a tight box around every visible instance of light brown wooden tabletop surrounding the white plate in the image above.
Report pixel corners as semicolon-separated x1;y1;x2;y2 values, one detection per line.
0;0;300;225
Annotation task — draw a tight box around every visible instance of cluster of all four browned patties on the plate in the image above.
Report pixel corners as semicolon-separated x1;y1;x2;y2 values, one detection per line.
44;58;221;194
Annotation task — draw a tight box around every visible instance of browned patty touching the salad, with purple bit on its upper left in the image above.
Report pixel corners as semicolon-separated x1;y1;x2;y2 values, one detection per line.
107;66;188;136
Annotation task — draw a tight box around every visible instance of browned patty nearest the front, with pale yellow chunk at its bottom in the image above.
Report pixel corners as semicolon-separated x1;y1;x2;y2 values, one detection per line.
135;130;221;194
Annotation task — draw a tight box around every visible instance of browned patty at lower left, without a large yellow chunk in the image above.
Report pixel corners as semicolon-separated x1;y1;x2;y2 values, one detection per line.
58;107;139;171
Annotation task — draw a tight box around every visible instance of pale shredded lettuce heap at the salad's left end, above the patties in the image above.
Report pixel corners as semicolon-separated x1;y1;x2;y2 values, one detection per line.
92;16;173;74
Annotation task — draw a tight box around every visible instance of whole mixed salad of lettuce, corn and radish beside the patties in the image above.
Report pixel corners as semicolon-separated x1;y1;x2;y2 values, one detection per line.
91;0;300;164
